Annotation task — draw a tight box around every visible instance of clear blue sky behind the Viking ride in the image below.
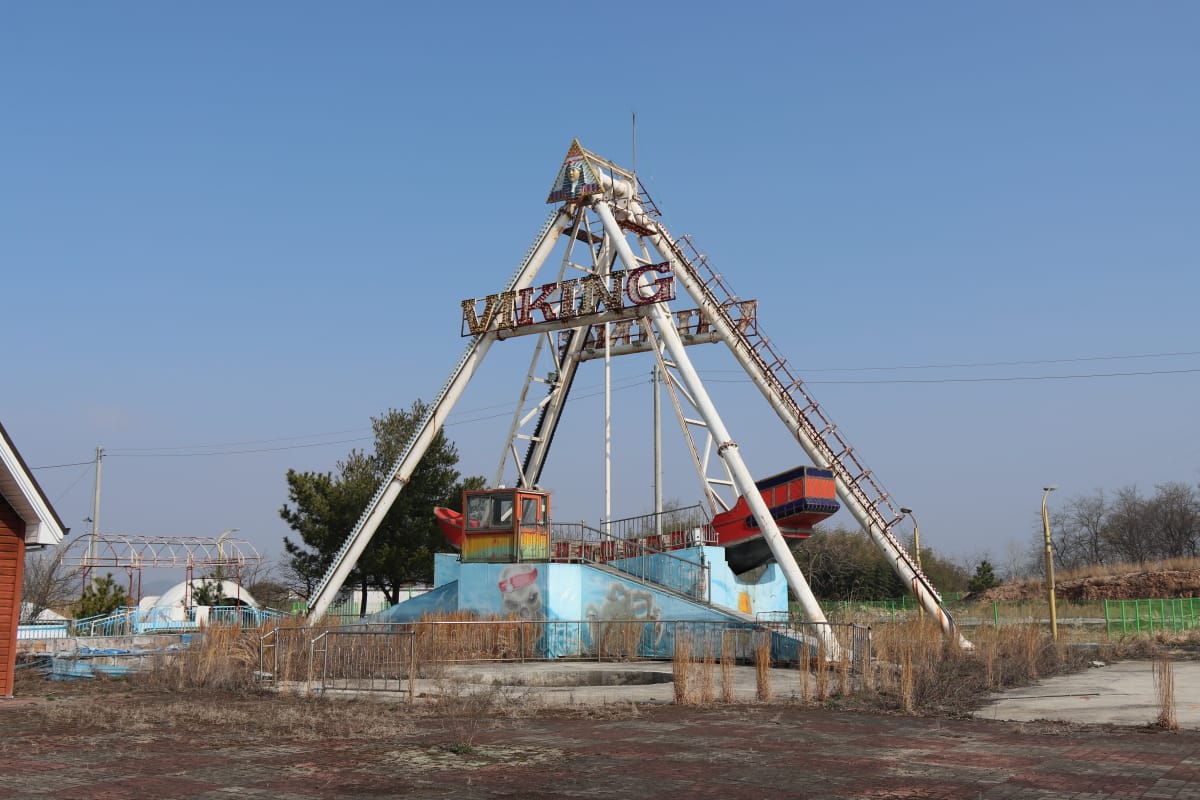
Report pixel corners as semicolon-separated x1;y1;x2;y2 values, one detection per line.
0;2;1200;575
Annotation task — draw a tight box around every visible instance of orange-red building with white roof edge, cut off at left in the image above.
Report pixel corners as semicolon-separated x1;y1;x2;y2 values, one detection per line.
0;425;66;697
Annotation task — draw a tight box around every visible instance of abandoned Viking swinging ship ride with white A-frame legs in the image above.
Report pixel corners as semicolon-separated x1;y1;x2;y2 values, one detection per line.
308;140;970;646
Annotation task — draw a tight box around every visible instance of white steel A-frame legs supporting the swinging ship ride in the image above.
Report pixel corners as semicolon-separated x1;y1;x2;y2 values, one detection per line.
308;137;971;646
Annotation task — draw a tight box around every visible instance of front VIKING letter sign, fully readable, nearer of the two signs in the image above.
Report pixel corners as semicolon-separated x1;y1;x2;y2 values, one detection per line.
462;263;674;336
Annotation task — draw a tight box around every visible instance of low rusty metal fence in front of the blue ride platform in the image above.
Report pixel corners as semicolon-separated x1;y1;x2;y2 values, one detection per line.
258;614;871;697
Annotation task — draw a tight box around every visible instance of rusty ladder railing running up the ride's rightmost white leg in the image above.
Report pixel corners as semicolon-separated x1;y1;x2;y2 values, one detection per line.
654;212;941;603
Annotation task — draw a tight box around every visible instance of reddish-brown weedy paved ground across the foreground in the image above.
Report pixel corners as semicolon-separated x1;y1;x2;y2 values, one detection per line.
0;684;1200;800
